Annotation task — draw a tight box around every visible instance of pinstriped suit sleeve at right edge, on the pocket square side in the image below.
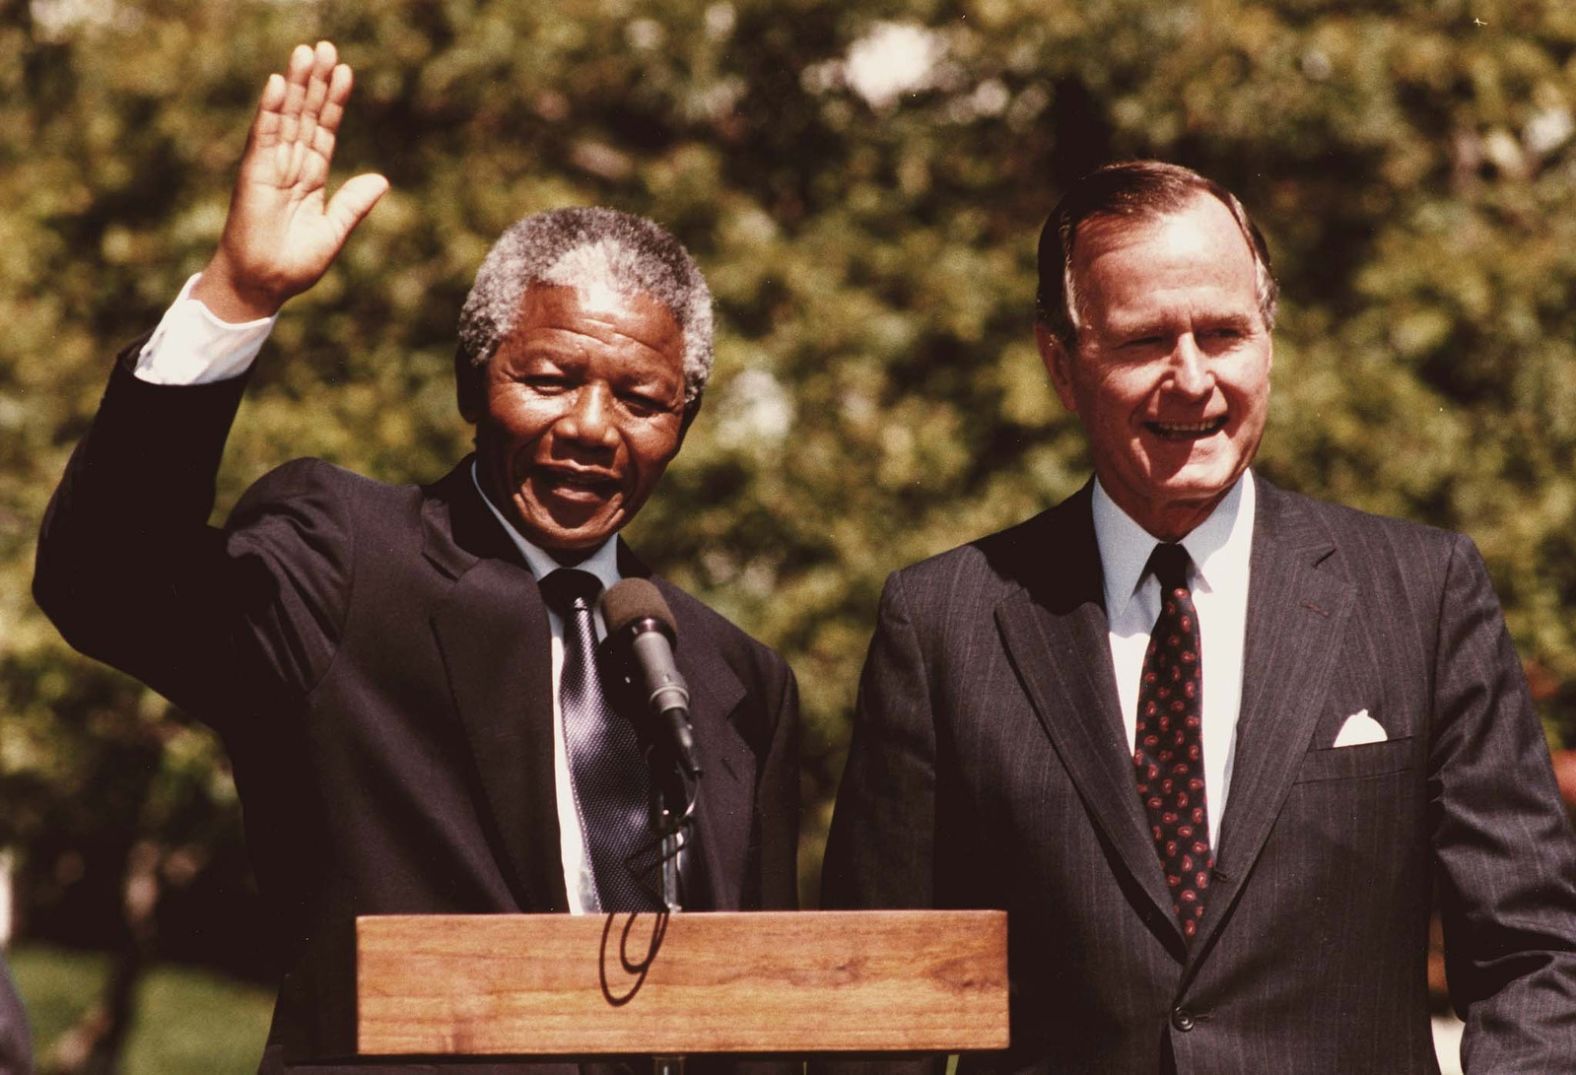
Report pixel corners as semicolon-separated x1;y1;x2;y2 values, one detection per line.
1429;538;1576;1072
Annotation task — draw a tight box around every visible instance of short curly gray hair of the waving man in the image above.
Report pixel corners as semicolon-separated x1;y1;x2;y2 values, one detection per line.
455;208;712;416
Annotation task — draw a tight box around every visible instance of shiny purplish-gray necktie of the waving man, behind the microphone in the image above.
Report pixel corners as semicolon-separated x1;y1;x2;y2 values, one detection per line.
541;569;657;911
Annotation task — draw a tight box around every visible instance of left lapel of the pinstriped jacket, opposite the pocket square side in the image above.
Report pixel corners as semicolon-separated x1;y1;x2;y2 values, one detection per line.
996;485;1182;926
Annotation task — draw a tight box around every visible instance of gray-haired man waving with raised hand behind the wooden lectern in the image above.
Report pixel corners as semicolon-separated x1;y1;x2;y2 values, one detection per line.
35;43;797;1072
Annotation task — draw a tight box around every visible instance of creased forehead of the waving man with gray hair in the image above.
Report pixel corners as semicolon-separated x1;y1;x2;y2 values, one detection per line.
498;284;684;372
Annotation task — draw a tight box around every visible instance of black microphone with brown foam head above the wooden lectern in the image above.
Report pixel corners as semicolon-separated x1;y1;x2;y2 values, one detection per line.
600;578;700;780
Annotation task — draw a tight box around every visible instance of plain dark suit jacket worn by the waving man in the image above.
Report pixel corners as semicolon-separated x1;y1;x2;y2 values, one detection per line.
35;347;797;1070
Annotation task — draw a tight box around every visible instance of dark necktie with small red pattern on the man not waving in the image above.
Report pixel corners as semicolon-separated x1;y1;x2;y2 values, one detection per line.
1133;544;1215;939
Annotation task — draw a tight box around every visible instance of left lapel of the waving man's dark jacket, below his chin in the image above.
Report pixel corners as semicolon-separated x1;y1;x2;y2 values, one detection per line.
422;459;569;911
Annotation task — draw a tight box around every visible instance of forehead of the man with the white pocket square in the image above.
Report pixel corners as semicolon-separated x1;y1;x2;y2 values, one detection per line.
1072;194;1258;325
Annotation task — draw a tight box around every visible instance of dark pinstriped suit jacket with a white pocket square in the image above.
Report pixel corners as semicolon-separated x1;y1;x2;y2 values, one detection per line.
824;481;1576;1075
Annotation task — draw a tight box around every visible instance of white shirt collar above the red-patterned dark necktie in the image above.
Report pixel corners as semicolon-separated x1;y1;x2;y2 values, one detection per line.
1092;470;1258;619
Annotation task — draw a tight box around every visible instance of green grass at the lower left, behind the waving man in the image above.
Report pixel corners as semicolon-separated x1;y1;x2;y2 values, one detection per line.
6;944;273;1075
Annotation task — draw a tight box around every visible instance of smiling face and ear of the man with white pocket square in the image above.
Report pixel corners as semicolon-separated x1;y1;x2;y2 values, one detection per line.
1035;195;1273;541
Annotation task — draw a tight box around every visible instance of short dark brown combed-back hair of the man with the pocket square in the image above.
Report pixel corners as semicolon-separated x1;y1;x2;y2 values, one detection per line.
1034;161;1280;352
